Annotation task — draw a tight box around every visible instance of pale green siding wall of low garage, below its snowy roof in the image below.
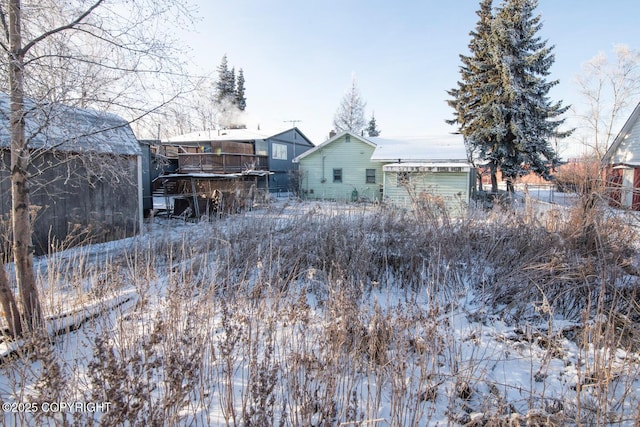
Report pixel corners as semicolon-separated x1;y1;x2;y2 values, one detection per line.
384;171;470;215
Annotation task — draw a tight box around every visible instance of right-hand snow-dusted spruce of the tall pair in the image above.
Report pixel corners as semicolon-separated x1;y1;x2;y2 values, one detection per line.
491;0;569;191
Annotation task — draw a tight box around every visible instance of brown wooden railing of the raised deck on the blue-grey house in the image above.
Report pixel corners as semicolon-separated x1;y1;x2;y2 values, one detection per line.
178;153;268;173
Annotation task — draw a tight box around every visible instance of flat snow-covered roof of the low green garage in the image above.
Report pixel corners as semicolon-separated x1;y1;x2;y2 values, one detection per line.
368;134;467;163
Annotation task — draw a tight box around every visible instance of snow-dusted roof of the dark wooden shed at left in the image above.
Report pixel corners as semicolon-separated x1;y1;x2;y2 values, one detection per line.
0;93;142;155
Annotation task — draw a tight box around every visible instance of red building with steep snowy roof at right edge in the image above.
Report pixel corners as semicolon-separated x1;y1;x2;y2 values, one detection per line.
602;103;640;210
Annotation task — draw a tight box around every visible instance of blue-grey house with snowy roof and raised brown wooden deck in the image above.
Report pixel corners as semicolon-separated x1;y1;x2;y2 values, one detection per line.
162;127;314;192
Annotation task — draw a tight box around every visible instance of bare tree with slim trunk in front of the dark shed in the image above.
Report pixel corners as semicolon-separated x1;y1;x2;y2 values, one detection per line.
0;0;191;334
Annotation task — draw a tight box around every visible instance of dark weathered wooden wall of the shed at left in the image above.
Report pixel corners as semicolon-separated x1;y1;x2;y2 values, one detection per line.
0;150;139;255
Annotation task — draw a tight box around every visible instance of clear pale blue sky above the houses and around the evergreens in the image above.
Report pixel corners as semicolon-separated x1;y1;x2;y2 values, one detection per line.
176;0;640;157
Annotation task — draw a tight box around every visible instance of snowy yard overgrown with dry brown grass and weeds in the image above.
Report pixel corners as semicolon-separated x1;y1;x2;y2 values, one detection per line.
0;196;640;426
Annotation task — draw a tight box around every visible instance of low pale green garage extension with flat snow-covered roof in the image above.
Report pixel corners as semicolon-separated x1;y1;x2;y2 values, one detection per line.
369;134;475;212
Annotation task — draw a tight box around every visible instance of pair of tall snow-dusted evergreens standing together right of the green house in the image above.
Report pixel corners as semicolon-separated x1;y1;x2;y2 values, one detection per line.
449;0;569;191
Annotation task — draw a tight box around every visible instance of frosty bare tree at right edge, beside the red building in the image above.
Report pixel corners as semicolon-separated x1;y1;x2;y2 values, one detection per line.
576;45;640;160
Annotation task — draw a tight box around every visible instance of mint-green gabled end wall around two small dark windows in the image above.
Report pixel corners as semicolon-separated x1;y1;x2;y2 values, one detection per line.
299;134;383;201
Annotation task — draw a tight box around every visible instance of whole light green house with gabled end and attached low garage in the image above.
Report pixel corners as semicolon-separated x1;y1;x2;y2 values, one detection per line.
294;132;474;211
